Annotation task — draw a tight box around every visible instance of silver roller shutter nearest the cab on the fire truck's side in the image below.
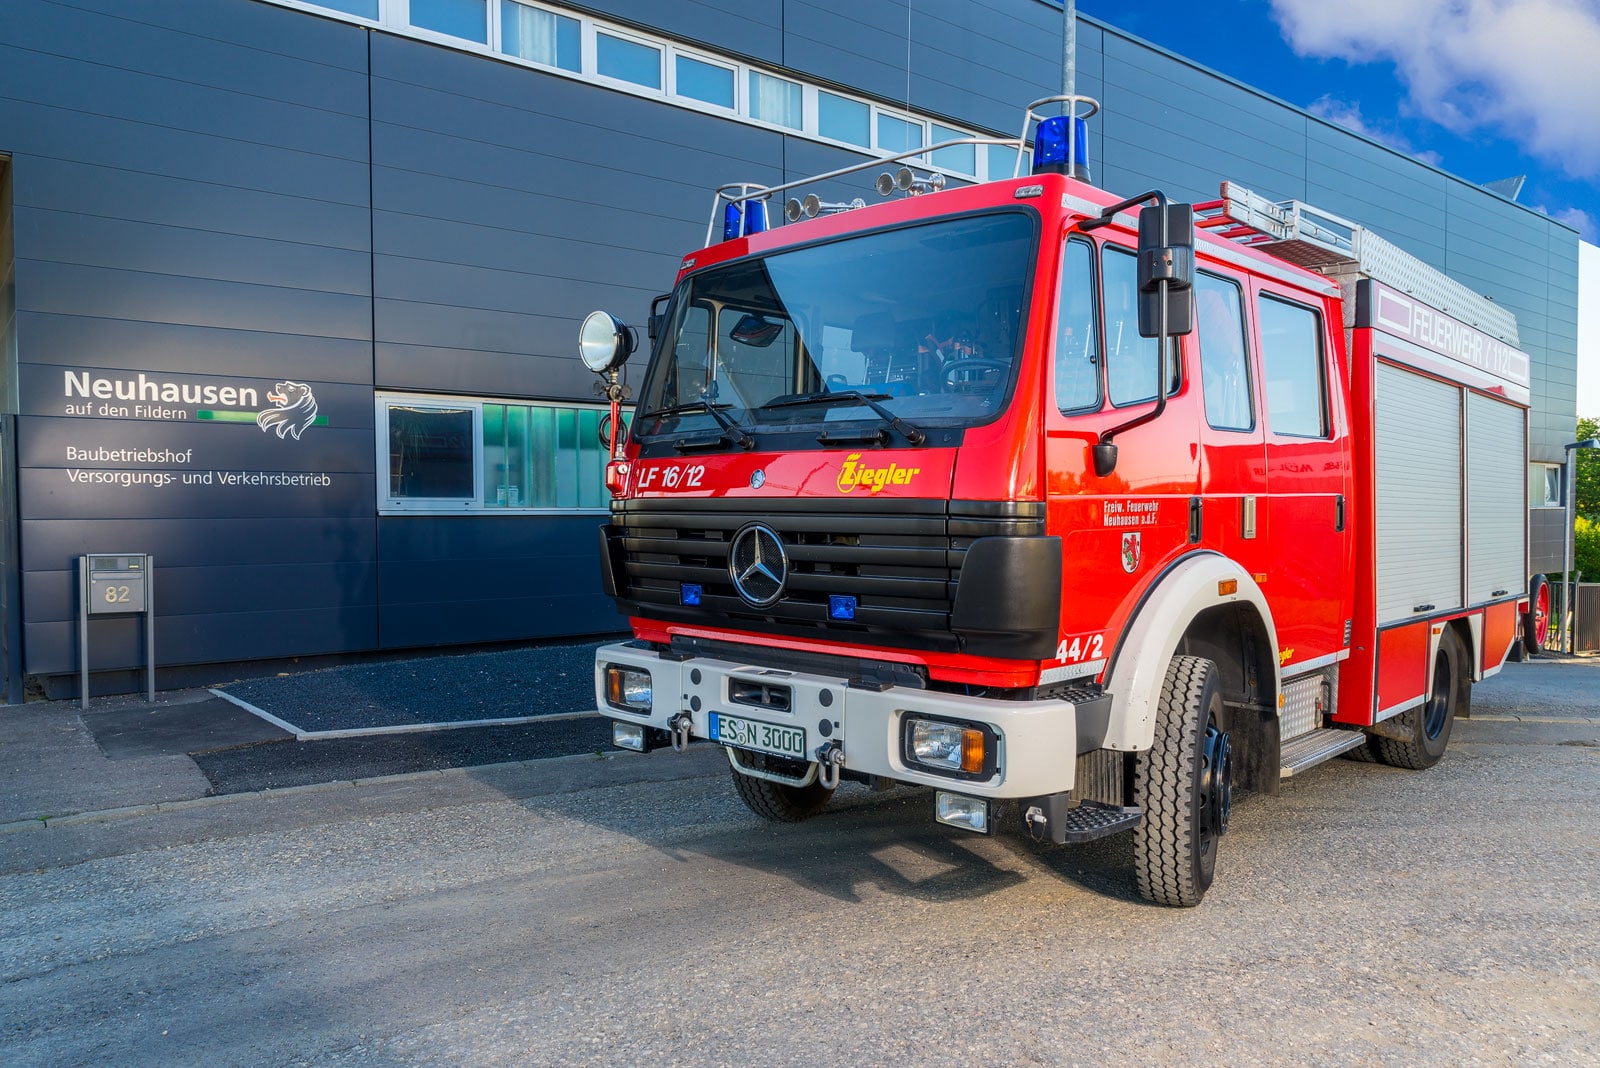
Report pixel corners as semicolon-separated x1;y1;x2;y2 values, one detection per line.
1374;363;1462;625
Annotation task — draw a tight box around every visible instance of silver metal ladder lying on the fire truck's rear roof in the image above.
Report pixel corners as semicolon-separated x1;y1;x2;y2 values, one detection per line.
1195;182;1518;347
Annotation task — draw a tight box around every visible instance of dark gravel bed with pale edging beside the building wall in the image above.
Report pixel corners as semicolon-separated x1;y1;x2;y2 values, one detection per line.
218;638;614;734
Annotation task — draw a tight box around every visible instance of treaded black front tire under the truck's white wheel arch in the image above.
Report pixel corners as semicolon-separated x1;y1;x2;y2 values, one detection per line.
1133;657;1234;908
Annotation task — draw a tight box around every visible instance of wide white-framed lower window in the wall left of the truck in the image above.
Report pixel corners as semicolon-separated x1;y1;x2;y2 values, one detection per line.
378;393;611;513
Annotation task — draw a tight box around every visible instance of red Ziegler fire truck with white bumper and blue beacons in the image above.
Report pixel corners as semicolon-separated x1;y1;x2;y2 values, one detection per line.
581;98;1534;905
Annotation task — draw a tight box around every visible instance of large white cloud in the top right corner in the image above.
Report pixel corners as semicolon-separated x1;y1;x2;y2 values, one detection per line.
1272;0;1600;177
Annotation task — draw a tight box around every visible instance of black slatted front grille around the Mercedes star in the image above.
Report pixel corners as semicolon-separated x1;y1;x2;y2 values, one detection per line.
608;497;1045;649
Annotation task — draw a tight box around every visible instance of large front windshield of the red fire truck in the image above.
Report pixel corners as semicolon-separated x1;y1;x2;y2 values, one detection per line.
634;211;1034;436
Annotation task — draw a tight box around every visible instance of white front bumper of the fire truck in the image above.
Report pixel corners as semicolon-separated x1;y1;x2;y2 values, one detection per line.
595;643;1110;798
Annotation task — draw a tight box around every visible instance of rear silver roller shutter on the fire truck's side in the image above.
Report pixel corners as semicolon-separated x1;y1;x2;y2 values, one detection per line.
1467;393;1528;604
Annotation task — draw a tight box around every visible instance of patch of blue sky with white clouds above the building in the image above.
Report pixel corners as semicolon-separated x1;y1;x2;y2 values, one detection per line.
1078;0;1600;241
